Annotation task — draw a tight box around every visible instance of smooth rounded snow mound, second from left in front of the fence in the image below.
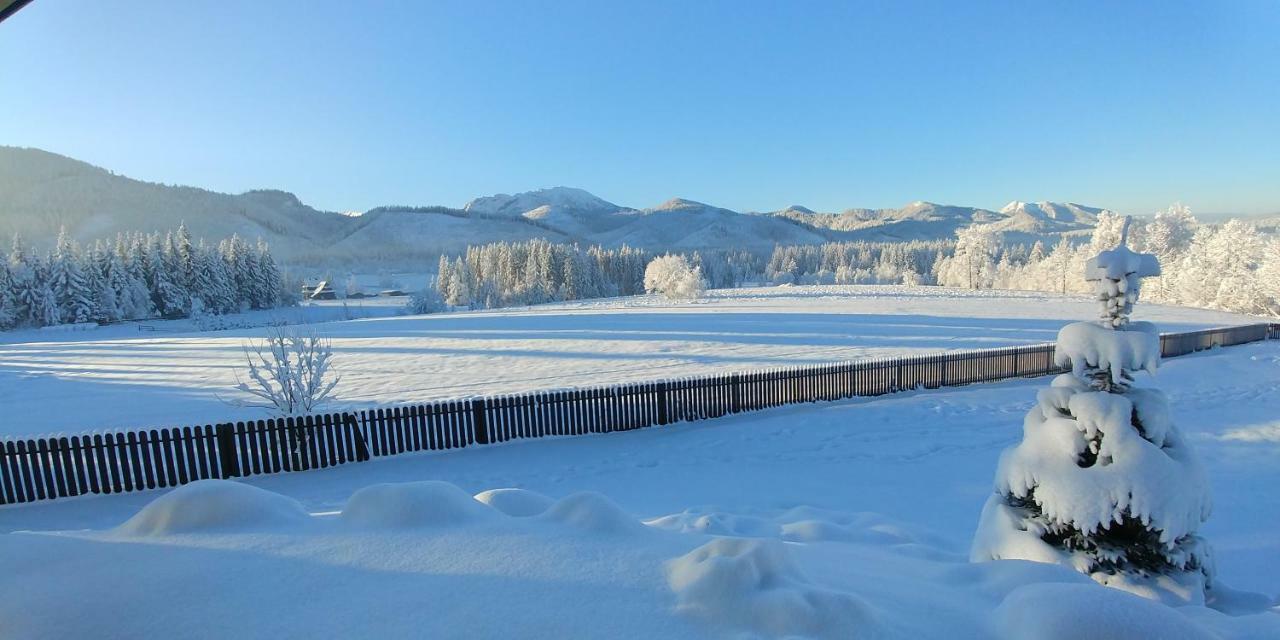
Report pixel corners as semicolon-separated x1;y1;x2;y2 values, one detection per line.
342;480;497;529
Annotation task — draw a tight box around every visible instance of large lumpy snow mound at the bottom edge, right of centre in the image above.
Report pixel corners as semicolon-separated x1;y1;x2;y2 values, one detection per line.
666;538;878;637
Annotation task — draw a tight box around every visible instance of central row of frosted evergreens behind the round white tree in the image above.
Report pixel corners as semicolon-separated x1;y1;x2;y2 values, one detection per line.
435;238;762;308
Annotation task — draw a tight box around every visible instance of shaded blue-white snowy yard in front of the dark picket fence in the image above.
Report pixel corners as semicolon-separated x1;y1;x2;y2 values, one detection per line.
0;337;1280;639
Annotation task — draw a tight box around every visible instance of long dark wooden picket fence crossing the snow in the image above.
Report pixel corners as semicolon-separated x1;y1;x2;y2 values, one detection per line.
0;324;1280;504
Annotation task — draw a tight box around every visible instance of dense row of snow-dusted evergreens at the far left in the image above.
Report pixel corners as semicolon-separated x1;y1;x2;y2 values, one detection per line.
0;225;297;329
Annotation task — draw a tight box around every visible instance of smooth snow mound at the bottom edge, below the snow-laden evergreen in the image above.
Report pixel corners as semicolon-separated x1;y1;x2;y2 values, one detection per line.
995;584;1215;640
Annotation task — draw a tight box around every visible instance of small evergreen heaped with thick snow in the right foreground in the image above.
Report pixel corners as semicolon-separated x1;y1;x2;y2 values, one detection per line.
972;218;1213;603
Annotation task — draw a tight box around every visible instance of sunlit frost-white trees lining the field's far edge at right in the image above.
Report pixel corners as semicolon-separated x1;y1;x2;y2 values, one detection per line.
763;205;1280;315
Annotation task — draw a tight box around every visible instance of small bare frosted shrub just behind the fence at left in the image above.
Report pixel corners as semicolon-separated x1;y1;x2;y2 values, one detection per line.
236;329;339;416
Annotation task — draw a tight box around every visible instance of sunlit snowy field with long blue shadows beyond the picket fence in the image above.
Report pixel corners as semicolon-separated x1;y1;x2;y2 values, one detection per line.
0;285;1258;435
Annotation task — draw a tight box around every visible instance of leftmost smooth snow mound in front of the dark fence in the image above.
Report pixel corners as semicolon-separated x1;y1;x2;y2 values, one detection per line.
115;480;311;536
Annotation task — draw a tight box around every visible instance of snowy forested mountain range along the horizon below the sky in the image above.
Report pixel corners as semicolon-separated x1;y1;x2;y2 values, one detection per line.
0;147;1102;266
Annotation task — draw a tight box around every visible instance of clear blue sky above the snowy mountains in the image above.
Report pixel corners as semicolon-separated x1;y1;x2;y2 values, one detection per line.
0;0;1280;214
